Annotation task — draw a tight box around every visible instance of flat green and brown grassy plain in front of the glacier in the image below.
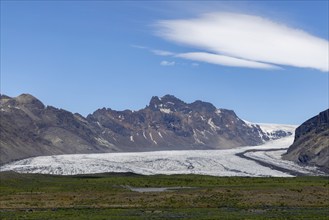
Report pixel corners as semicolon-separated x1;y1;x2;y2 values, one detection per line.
0;172;329;220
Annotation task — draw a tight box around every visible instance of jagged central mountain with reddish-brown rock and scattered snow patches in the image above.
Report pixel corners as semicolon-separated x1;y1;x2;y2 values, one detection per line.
87;95;263;151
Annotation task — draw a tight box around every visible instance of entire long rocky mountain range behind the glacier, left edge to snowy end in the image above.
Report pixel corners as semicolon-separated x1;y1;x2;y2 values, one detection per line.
0;94;292;164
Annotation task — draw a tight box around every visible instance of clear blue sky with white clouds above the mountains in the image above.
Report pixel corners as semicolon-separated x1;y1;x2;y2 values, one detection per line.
1;1;329;124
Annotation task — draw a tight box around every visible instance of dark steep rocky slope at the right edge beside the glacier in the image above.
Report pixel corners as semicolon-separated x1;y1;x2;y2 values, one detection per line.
283;109;329;172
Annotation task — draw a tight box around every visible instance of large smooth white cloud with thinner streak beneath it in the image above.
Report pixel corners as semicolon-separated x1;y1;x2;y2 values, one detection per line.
157;13;329;72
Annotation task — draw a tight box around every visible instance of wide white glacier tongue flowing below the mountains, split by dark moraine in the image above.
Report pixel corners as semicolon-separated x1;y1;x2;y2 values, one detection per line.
0;136;317;177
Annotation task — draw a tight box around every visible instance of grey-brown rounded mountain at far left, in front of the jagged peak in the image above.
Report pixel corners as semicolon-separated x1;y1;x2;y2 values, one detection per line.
0;94;112;163
